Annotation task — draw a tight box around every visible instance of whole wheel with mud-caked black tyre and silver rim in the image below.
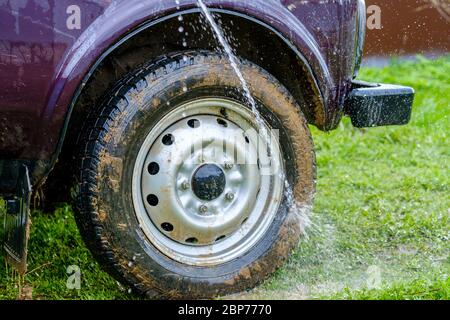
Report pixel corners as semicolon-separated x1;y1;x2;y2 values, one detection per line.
75;52;315;298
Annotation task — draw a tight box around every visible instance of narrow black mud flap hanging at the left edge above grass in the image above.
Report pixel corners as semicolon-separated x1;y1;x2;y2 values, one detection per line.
4;165;31;274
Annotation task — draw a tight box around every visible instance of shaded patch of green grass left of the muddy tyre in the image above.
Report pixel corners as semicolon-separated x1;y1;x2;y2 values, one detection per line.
0;206;132;299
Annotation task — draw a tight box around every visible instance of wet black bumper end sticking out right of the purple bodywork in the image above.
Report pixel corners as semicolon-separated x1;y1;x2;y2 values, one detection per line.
344;81;414;128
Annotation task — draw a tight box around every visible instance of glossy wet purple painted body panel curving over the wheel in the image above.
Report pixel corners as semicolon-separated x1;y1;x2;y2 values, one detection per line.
0;0;357;161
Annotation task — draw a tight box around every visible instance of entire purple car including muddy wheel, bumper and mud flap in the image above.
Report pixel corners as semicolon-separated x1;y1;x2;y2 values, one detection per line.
0;0;414;298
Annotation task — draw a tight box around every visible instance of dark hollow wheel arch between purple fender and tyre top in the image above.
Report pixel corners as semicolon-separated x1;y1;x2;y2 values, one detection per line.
62;9;328;148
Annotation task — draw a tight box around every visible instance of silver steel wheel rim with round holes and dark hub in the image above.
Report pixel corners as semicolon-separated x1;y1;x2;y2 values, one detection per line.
132;98;284;266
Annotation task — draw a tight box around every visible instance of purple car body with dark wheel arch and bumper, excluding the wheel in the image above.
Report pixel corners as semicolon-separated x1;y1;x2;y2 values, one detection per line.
0;0;413;296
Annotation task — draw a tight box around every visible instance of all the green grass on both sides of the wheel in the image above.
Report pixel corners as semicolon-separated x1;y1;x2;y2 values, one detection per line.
0;57;450;299
